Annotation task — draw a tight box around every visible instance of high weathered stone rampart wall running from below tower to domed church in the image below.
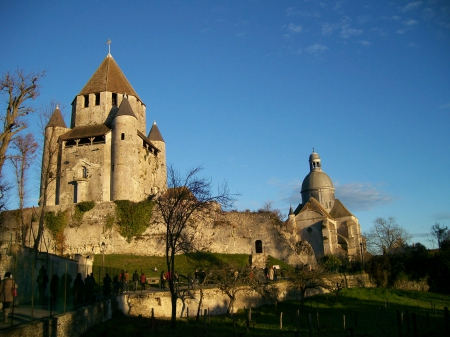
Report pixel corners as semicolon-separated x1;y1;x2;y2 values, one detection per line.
0;202;315;265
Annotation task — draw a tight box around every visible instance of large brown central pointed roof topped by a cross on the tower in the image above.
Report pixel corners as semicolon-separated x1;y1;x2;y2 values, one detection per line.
78;54;142;102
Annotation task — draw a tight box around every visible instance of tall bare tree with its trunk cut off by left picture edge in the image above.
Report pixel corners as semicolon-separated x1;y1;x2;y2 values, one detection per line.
0;70;45;176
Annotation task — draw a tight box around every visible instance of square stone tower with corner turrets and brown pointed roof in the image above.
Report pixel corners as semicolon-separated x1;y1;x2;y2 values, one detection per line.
40;54;166;205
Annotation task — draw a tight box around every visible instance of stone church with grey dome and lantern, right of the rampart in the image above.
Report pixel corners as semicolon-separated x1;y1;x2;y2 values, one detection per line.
286;150;362;259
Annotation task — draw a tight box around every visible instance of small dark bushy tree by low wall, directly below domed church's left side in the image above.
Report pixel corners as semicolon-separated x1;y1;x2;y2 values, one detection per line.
288;265;327;306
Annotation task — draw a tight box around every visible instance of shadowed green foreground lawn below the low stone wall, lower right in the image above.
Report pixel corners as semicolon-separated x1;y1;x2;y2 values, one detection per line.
85;288;450;337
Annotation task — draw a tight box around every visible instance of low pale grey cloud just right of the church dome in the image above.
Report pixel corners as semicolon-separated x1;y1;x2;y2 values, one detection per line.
335;183;394;212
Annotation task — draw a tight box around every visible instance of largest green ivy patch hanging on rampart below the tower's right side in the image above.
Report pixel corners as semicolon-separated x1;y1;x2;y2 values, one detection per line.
114;200;155;242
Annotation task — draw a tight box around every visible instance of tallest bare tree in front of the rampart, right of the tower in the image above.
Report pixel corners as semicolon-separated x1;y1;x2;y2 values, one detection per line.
156;166;234;327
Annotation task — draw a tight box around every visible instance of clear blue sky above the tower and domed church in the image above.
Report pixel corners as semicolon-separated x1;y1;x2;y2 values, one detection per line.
0;0;450;245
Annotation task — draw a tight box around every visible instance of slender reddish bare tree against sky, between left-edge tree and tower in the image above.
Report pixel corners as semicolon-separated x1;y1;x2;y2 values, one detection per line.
10;133;38;246
